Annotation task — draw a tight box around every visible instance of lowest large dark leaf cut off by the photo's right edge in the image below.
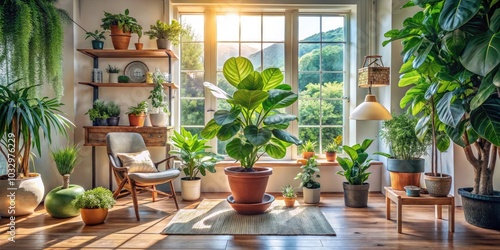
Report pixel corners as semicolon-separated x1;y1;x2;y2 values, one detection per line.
470;98;500;146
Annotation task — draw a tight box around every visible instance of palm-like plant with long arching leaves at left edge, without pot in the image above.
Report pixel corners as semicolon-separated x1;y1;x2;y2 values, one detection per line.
0;81;74;178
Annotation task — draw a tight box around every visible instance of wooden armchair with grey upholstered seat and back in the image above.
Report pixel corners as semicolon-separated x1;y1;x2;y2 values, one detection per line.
106;132;180;220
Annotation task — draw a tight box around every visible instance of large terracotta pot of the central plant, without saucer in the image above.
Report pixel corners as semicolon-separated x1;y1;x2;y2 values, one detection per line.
224;167;273;203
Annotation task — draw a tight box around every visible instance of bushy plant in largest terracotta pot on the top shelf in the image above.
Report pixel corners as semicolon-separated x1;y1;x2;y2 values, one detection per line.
101;9;142;50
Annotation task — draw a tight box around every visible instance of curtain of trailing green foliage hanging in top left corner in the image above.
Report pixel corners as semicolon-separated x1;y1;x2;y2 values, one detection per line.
0;0;64;98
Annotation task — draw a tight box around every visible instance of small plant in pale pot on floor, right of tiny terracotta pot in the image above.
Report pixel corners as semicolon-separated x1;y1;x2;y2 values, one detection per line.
295;156;321;204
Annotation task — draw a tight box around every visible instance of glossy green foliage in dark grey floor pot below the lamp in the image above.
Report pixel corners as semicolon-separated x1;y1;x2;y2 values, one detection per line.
337;139;373;185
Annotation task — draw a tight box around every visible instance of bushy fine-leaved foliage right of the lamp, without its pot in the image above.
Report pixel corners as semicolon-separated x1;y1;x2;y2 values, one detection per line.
377;113;432;160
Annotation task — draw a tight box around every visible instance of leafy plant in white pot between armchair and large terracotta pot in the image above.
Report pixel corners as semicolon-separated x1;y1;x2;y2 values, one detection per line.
169;127;224;201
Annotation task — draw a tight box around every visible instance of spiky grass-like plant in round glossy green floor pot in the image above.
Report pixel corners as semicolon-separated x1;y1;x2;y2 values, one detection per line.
44;145;85;218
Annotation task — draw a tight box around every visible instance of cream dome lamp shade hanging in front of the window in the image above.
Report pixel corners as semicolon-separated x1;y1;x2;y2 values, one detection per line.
349;94;392;120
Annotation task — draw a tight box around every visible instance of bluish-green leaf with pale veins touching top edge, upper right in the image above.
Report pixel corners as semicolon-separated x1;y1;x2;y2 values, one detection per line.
439;0;482;31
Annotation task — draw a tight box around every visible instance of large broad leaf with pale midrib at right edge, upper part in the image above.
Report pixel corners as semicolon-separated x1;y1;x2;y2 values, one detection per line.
460;32;500;76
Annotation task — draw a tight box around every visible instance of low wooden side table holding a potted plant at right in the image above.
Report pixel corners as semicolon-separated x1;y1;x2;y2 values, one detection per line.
385;187;455;233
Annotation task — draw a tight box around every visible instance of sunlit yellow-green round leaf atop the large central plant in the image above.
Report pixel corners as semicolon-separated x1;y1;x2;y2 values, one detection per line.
222;57;254;88
